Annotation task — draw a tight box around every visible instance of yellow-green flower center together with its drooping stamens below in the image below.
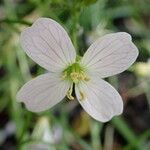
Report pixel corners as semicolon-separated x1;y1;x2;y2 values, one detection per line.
61;62;90;100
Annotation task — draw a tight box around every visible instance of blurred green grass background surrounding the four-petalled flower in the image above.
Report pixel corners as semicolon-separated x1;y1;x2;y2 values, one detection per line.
0;0;150;150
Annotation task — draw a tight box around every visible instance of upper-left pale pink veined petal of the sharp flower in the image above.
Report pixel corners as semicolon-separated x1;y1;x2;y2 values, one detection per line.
20;18;76;72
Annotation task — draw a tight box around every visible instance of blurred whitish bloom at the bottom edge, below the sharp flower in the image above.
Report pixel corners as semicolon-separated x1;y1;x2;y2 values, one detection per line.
23;116;63;150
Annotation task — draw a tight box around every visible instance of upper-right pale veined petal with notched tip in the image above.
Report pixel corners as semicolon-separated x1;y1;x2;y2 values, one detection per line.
81;32;138;78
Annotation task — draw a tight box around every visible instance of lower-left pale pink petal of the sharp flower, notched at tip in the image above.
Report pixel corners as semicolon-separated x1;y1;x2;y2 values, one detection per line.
17;73;70;112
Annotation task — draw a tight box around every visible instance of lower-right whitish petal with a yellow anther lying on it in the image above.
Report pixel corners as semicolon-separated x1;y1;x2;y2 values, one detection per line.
75;78;123;122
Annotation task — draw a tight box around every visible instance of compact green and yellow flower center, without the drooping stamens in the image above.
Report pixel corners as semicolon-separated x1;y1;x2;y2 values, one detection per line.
61;63;89;84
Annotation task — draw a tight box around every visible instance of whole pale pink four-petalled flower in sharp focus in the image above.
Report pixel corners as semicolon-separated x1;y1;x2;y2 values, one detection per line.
17;18;138;122
